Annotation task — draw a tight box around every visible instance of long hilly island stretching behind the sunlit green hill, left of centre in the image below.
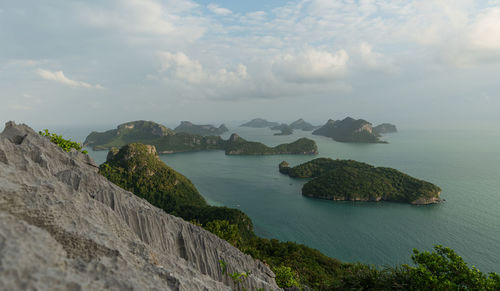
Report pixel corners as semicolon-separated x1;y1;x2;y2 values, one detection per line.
84;120;318;155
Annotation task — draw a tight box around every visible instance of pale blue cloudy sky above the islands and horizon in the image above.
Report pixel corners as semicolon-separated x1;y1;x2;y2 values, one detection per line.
0;0;500;127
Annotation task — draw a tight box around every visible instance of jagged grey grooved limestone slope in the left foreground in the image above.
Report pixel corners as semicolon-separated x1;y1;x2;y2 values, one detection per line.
0;122;280;291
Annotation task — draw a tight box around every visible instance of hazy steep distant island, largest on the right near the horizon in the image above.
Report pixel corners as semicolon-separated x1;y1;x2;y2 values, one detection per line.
312;117;387;143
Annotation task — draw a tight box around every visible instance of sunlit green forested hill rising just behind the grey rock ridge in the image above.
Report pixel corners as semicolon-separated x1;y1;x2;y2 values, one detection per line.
99;144;253;238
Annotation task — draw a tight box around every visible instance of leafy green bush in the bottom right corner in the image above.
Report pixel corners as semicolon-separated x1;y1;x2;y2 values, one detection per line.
404;245;500;290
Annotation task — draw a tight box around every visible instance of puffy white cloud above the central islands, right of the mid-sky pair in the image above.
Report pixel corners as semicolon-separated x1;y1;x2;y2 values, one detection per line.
272;48;349;83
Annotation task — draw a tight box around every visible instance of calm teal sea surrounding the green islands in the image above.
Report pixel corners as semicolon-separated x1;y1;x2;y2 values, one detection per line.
65;128;500;272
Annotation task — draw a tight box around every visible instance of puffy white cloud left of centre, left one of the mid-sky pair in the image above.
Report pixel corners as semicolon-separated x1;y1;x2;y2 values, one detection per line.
158;52;248;85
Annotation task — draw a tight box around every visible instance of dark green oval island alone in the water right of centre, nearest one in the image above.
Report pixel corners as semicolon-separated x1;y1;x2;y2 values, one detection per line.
279;158;441;205
